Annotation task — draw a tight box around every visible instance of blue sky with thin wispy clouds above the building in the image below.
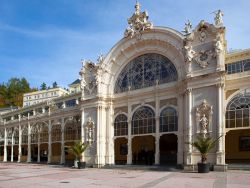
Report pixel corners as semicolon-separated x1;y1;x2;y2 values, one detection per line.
0;0;250;87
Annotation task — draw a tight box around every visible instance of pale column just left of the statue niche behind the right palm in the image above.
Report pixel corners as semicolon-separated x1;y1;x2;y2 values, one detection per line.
185;88;193;165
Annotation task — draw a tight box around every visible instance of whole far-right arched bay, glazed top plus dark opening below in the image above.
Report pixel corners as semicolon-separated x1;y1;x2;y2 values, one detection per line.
225;89;250;163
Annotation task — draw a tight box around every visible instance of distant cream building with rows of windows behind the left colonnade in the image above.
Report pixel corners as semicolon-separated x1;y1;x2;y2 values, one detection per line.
23;87;68;107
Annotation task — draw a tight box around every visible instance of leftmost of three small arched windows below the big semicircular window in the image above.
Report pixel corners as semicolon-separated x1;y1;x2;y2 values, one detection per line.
114;114;128;136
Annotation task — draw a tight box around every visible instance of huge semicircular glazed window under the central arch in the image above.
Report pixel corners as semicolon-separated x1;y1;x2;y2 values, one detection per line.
114;53;178;93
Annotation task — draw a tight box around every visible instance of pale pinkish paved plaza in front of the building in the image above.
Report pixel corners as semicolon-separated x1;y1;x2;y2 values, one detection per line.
0;163;250;188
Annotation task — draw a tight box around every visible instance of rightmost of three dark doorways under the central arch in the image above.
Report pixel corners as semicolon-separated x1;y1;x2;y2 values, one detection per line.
160;134;178;165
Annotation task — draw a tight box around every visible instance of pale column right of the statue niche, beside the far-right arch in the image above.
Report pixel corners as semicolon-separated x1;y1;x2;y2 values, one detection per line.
216;83;225;165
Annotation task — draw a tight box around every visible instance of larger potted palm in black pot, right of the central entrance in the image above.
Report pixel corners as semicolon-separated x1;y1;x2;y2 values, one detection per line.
189;136;221;173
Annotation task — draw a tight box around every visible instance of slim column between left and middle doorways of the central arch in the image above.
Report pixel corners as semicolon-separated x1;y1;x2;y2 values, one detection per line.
127;102;133;165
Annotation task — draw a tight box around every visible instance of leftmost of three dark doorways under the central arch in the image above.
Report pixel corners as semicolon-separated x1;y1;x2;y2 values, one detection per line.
115;137;128;165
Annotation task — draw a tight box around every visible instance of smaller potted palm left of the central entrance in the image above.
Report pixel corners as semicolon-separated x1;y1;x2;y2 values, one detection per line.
65;141;88;169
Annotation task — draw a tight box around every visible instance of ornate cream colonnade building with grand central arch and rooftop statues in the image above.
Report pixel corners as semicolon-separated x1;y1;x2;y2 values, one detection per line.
0;3;250;170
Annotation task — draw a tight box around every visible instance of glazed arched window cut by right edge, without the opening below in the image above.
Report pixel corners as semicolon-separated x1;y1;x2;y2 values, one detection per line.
226;89;250;128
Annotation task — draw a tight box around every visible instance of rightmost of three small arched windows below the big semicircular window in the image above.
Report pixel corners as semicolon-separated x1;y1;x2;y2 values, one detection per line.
160;107;178;132
